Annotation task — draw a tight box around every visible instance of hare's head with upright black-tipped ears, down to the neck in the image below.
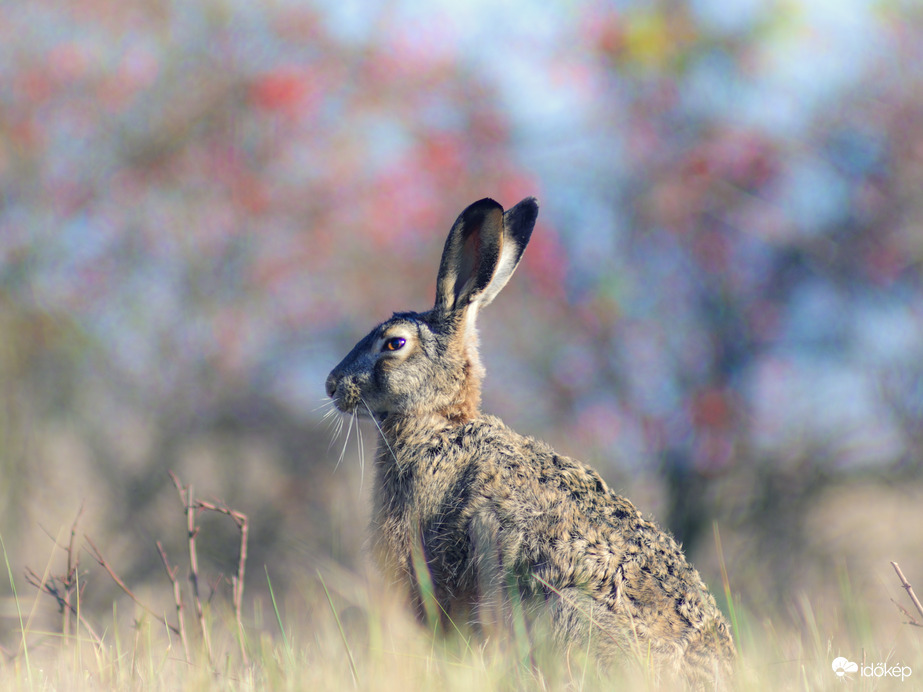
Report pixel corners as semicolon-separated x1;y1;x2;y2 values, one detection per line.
327;197;538;422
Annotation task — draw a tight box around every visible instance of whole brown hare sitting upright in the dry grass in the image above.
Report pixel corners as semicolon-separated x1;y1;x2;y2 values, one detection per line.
326;197;734;687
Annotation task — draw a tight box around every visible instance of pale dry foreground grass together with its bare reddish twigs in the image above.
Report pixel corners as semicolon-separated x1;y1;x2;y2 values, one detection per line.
0;479;923;692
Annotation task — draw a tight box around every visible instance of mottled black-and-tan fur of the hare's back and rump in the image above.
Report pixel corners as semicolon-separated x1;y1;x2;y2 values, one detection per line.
476;419;717;620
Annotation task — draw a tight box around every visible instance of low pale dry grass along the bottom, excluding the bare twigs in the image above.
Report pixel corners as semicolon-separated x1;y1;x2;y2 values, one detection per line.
0;575;923;692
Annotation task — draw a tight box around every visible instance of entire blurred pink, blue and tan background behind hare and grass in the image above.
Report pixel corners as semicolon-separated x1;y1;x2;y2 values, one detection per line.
0;0;923;660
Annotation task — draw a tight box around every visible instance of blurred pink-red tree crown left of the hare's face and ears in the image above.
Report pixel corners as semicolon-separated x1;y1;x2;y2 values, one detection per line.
0;0;537;612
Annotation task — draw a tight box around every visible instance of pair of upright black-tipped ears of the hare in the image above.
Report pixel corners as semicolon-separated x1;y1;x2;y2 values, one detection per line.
436;197;538;312
